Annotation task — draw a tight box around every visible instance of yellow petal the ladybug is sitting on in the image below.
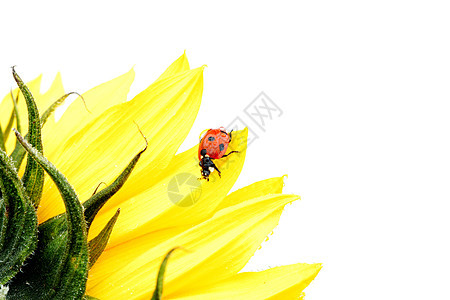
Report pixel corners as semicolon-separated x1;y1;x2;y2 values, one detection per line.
90;129;248;246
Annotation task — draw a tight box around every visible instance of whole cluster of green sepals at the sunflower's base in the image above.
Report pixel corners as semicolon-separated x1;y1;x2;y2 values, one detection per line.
0;68;171;299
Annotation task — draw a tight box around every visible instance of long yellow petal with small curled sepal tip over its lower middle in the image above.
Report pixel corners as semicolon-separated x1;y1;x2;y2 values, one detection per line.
87;191;298;299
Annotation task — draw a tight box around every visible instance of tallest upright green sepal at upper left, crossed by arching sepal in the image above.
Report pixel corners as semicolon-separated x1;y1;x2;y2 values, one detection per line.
12;67;44;207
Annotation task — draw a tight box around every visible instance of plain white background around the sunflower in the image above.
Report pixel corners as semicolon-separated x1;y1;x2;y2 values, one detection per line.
0;1;450;300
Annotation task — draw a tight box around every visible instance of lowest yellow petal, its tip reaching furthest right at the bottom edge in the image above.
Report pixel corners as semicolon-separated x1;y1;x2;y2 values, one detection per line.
171;262;322;300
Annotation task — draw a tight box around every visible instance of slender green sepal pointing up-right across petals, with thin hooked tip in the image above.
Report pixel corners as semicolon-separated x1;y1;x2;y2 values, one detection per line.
83;137;148;228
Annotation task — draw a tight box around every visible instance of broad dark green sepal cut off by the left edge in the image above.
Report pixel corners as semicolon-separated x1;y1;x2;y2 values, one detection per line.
0;150;38;285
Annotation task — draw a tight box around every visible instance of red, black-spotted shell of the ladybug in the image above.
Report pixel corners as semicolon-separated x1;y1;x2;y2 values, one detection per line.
198;129;230;160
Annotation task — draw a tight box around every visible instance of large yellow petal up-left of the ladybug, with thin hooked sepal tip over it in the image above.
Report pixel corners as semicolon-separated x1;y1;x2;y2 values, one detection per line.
39;68;203;221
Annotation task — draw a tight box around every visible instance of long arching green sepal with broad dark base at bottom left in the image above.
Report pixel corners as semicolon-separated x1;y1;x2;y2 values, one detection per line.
8;131;89;299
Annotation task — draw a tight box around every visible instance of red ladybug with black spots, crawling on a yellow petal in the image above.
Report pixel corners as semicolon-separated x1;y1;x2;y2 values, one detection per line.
198;127;239;181
